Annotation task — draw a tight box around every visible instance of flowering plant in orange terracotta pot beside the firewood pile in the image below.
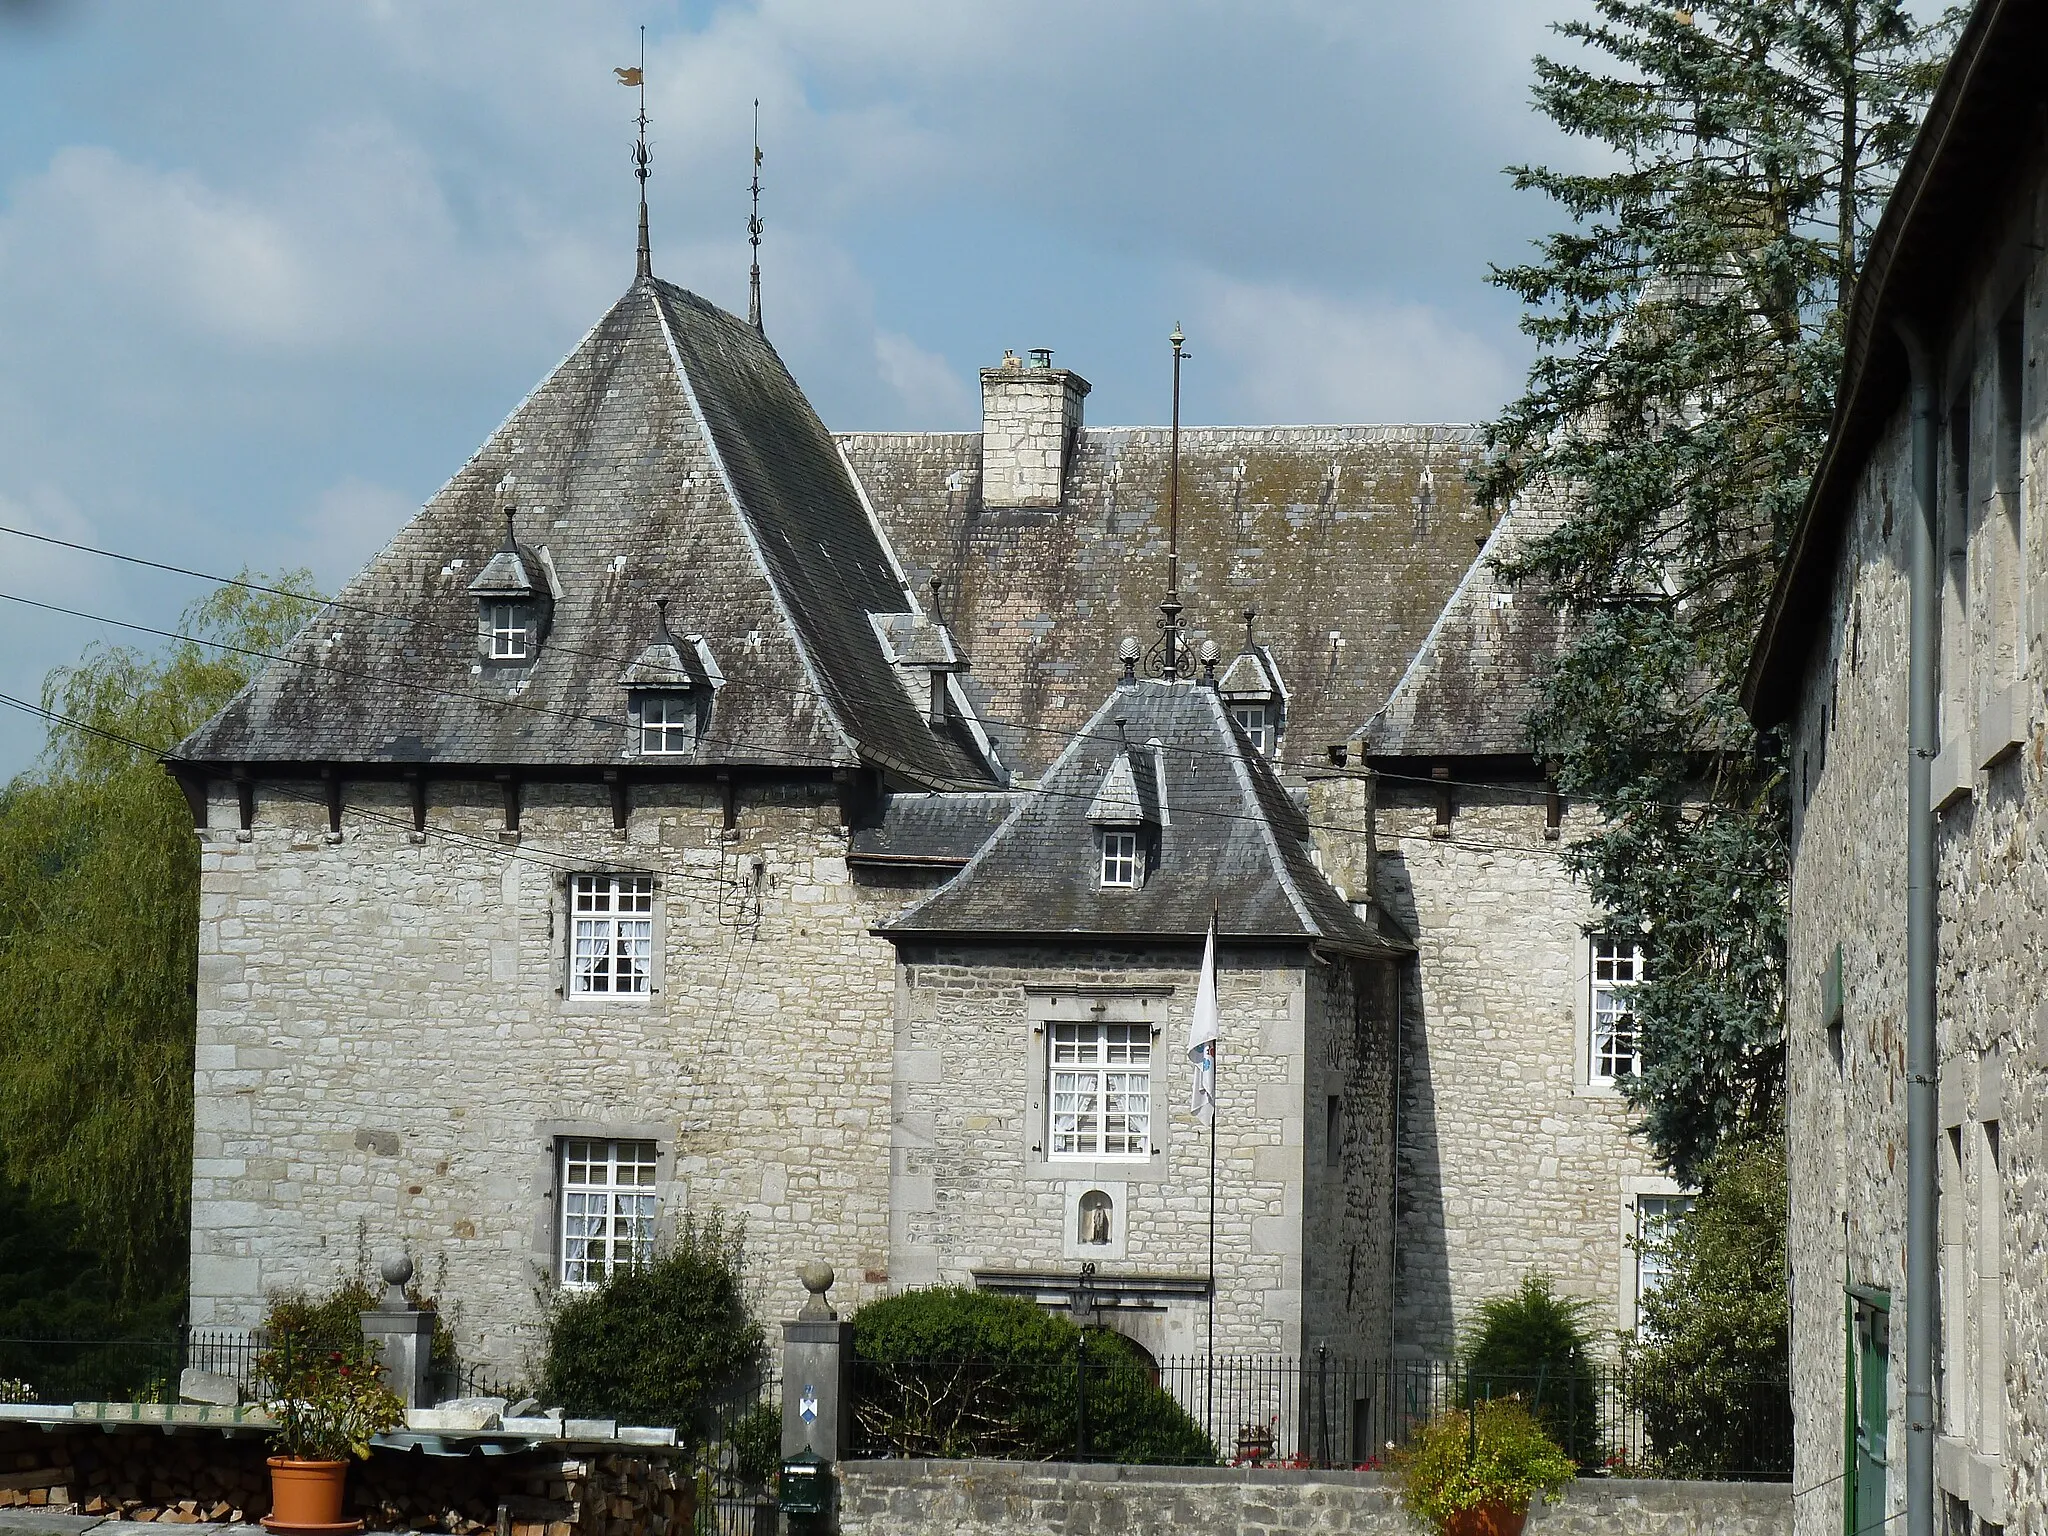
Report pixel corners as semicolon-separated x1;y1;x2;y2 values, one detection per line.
256;1307;406;1532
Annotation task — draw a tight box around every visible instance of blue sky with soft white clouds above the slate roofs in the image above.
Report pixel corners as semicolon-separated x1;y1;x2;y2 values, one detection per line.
0;0;1587;778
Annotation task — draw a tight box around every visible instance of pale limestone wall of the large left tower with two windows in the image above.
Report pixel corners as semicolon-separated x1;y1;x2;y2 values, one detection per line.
193;782;929;1372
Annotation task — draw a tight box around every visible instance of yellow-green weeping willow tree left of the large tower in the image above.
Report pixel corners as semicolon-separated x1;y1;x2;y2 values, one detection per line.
0;571;313;1307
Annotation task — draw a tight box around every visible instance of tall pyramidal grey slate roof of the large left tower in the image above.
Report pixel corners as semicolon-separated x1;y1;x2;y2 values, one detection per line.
180;279;993;786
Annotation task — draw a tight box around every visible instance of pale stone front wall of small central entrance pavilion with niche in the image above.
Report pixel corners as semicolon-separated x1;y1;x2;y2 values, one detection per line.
889;944;1311;1358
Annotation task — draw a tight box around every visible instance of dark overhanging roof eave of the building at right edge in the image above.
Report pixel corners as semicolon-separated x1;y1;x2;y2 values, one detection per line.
1743;0;2048;725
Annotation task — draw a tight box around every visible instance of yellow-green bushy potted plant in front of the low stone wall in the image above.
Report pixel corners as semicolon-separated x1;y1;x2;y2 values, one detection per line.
1395;1399;1573;1536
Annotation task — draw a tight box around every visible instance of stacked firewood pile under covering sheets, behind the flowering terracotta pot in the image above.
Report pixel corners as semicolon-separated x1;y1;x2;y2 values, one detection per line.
0;1425;694;1536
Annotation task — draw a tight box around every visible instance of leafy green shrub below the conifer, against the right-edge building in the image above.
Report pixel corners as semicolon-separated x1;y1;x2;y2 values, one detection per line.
1624;1135;1792;1473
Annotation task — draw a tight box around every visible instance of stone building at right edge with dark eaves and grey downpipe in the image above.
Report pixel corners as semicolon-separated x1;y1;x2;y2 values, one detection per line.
1749;0;2048;1532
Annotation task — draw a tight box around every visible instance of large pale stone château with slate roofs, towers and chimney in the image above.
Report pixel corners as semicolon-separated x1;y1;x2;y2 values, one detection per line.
168;217;1681;1368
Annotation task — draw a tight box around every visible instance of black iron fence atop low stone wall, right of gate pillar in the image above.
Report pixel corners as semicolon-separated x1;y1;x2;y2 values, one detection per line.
850;1343;1792;1481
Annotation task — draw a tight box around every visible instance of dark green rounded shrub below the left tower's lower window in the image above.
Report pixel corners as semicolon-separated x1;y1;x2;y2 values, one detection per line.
539;1210;766;1438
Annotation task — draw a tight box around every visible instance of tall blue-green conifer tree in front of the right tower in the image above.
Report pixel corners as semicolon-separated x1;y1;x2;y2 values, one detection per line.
1479;0;1954;1178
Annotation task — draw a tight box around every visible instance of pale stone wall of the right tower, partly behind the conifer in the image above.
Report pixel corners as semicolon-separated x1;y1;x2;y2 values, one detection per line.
1359;778;1677;1356
